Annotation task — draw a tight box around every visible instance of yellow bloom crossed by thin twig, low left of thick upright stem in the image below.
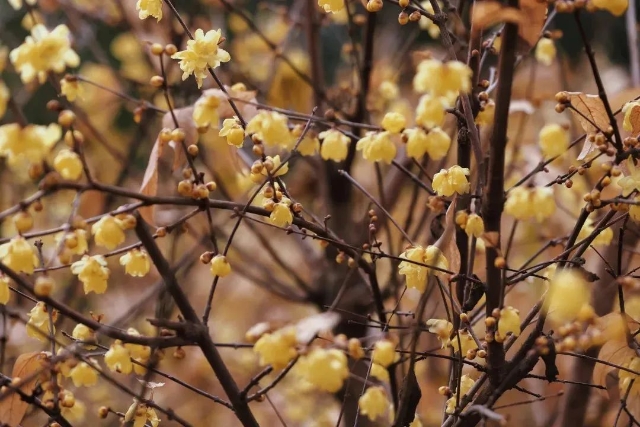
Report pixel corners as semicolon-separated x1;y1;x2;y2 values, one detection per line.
398;245;449;292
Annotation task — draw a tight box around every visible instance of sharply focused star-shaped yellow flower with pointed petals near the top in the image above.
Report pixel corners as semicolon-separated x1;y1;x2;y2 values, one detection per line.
171;28;231;88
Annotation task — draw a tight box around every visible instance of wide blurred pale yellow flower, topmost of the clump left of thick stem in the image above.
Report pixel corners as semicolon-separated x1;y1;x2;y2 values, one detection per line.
413;59;473;97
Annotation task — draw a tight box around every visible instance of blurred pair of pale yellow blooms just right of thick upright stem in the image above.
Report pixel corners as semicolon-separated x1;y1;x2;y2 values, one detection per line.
504;187;556;222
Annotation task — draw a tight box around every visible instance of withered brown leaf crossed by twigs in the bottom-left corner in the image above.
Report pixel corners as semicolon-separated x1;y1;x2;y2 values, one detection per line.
0;351;45;427
